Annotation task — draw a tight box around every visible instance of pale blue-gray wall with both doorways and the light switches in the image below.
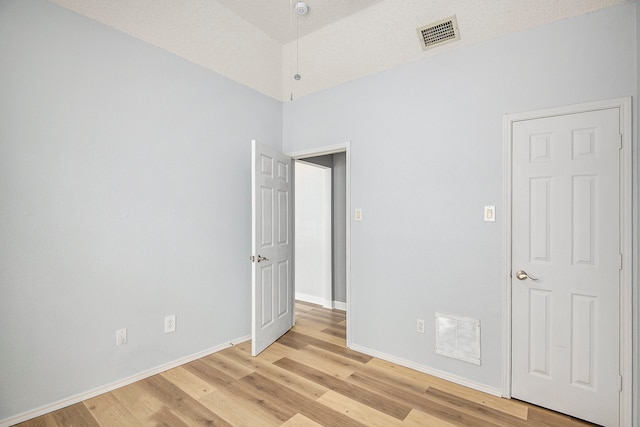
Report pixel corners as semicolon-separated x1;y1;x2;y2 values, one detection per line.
283;2;638;389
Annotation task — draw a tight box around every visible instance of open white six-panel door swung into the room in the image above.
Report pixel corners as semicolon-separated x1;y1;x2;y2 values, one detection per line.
251;141;294;356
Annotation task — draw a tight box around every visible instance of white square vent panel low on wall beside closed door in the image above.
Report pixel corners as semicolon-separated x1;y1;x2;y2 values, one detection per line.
436;313;480;365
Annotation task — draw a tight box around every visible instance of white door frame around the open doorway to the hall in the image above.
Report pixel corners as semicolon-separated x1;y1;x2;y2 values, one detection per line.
286;141;351;348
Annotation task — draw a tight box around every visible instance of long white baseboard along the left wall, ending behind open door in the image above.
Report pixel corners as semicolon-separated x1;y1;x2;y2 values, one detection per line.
0;335;251;427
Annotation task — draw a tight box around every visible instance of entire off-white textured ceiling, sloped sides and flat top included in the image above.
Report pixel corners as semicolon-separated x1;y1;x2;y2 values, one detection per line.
46;0;638;101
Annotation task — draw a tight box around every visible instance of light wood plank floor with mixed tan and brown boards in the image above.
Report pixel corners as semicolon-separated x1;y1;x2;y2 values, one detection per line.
19;303;591;427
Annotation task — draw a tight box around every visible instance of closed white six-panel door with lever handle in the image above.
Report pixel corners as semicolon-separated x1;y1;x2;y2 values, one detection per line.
511;108;621;426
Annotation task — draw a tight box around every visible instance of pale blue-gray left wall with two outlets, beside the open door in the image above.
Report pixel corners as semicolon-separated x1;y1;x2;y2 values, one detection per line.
0;0;282;420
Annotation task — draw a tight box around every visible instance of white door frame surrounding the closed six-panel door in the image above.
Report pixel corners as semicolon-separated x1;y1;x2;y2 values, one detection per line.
502;97;635;426
